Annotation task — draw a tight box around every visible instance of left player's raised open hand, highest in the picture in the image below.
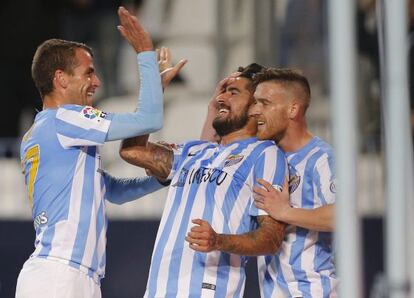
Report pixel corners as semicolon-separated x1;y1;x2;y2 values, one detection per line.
117;6;154;53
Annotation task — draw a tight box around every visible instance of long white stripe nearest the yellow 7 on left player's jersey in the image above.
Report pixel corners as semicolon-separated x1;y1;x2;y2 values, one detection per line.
49;148;87;260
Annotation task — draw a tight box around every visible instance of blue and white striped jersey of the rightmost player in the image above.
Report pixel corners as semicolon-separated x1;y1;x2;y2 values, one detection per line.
258;137;337;297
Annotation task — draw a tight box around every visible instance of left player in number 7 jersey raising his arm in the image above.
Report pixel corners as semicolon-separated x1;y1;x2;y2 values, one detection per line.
16;7;181;298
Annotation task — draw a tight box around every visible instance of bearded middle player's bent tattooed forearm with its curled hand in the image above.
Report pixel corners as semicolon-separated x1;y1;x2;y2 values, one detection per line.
185;215;285;256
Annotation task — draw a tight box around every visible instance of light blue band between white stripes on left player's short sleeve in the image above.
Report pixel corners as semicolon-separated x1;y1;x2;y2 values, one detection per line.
55;119;106;144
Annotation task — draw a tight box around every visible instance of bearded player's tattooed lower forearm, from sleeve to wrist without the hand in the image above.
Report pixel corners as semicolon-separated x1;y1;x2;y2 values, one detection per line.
217;216;285;256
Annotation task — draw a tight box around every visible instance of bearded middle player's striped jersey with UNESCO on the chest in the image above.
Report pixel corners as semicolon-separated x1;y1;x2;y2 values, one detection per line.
145;138;287;297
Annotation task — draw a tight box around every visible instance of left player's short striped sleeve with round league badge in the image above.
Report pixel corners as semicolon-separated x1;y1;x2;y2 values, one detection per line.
55;105;113;148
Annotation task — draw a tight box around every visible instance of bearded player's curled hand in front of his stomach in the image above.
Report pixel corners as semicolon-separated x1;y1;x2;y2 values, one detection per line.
185;218;218;252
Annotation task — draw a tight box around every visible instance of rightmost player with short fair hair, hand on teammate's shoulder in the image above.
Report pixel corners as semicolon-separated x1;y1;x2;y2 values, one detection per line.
199;68;337;298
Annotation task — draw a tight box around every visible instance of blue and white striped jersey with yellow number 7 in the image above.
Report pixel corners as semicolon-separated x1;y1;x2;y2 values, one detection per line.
20;105;113;281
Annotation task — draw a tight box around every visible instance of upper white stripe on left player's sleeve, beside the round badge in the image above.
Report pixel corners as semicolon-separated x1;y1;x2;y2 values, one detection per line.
56;108;111;133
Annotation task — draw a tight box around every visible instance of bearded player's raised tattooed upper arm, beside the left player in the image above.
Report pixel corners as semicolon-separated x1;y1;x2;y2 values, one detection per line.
119;135;173;179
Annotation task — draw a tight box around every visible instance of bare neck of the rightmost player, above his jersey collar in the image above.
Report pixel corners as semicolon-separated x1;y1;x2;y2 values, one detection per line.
277;121;313;152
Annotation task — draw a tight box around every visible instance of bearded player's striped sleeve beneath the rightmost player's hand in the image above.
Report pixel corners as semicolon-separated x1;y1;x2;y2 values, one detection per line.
249;145;288;216
